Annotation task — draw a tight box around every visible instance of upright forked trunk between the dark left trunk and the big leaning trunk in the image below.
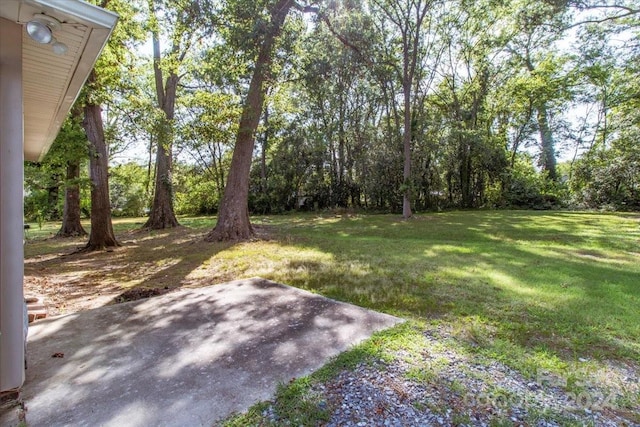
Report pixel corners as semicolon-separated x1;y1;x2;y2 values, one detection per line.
142;28;180;230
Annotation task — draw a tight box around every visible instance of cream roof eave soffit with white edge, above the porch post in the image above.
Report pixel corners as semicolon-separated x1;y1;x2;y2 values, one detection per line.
0;0;118;161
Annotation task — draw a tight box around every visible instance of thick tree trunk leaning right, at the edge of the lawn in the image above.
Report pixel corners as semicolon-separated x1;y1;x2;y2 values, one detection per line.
205;0;293;241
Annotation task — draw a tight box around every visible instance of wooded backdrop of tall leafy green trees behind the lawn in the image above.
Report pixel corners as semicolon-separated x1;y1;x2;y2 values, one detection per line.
25;0;640;240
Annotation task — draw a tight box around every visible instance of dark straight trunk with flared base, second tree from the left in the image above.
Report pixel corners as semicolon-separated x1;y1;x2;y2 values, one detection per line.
82;71;120;251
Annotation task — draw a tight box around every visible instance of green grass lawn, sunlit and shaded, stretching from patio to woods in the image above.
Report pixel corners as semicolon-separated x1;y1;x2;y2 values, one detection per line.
25;211;640;422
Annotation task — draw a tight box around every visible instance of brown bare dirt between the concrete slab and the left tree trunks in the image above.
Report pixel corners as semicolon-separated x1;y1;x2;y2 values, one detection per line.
24;227;245;316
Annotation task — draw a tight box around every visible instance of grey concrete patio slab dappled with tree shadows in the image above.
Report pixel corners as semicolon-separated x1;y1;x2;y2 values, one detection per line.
0;278;402;427
